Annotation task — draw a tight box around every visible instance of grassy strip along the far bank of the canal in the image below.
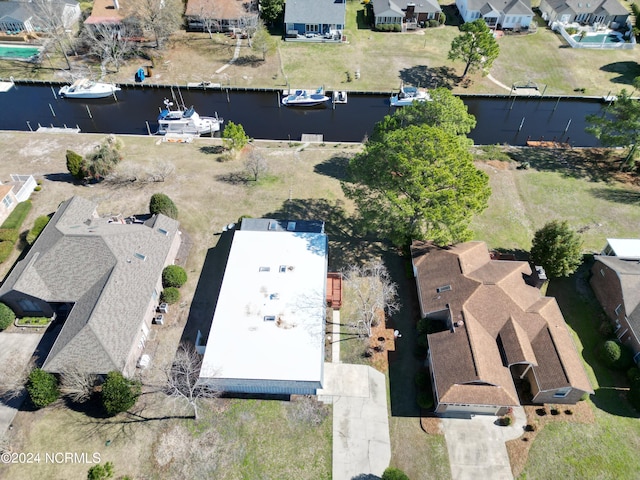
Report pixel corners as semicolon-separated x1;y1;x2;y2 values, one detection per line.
0;0;640;96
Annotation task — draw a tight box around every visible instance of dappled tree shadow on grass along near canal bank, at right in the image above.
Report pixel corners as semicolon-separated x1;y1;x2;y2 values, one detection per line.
508;148;620;182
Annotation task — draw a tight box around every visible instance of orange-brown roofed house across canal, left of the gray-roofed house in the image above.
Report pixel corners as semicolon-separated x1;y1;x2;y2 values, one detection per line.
184;0;258;32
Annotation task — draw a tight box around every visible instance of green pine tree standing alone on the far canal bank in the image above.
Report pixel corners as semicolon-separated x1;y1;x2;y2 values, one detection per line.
449;18;500;78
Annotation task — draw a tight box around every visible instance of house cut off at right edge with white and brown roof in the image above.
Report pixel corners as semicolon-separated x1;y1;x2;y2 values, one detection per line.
591;238;640;364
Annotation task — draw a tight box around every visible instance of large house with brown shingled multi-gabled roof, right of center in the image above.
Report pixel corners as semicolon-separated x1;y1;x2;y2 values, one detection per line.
411;241;593;415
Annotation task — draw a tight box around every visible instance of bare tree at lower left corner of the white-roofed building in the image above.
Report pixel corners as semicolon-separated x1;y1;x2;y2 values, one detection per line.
165;343;220;420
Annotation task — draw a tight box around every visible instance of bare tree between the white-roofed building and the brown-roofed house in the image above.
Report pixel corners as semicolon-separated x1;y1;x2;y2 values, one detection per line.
344;259;400;337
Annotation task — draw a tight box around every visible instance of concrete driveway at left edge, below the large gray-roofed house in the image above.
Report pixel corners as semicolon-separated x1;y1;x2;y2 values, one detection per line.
0;332;42;435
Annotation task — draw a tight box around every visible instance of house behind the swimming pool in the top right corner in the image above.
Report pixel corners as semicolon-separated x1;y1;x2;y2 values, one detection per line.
540;0;630;28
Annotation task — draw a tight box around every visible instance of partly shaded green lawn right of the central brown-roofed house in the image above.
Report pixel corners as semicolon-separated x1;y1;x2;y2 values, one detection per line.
521;268;640;480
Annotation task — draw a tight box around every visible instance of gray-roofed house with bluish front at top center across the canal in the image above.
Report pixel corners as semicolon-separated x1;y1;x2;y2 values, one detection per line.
284;0;347;41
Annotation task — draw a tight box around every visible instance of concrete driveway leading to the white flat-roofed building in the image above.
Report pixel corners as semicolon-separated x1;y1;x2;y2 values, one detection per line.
318;363;391;480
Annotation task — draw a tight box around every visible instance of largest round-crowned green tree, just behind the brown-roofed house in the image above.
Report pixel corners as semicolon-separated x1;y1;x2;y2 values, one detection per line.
342;124;491;245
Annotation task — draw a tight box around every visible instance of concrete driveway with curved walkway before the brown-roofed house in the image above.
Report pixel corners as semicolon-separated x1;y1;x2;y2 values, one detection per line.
441;407;526;480
